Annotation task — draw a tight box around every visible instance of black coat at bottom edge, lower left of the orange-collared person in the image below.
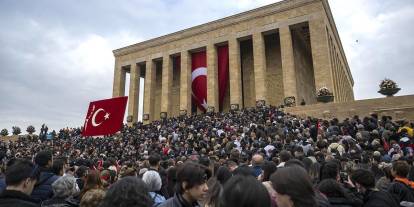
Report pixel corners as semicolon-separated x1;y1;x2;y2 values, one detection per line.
364;190;400;207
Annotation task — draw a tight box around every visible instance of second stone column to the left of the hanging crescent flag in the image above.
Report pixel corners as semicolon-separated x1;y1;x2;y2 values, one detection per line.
161;54;173;118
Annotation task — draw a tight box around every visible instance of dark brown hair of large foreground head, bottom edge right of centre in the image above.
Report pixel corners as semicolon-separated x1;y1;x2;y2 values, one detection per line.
270;166;316;207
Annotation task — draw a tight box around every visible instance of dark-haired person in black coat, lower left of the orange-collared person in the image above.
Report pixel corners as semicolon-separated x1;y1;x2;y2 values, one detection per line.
351;169;399;207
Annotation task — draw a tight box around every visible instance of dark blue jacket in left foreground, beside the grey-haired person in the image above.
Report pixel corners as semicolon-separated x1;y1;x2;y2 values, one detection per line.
31;171;59;203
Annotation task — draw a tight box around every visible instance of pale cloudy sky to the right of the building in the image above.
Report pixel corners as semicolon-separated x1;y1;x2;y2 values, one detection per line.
330;0;414;99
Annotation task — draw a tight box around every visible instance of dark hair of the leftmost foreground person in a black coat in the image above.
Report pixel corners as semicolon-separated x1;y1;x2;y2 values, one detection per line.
5;160;40;186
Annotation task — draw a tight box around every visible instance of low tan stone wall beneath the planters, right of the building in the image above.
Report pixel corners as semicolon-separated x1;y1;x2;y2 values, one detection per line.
284;95;414;121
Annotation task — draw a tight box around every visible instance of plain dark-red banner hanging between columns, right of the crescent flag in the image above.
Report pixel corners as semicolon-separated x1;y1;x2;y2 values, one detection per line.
217;45;229;109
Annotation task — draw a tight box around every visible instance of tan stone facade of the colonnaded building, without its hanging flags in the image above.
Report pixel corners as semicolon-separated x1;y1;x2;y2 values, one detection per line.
113;0;354;123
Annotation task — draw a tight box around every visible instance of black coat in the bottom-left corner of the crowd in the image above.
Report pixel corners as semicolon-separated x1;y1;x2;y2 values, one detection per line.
0;190;39;207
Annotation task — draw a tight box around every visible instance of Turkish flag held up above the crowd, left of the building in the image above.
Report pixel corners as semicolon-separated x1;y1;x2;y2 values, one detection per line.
82;96;128;136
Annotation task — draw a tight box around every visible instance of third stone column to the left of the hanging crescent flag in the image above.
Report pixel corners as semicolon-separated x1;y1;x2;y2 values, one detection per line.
143;59;156;124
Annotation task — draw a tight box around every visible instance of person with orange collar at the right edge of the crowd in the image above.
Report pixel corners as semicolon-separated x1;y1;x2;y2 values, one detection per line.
387;160;414;203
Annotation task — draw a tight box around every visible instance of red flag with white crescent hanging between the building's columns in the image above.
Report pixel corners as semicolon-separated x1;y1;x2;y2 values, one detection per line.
191;51;207;112
